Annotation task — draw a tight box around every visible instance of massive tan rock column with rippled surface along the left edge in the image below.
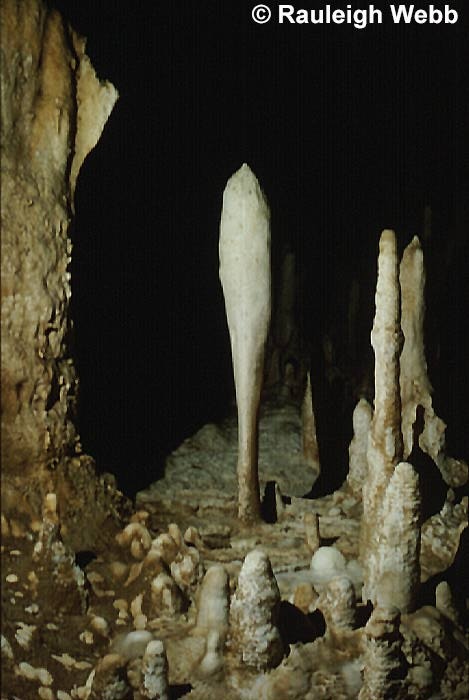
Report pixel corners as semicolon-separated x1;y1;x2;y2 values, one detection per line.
1;0;117;482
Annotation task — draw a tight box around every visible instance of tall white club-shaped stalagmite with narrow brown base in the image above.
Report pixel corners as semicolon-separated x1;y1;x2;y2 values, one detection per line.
219;163;271;522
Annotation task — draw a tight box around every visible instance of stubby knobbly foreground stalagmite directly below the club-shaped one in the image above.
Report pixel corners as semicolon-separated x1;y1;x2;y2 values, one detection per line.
230;550;283;670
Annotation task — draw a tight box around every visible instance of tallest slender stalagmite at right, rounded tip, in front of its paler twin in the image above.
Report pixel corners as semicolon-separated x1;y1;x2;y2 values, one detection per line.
360;230;402;602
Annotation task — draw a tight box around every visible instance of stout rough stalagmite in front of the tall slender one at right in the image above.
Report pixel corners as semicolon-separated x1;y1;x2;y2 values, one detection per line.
371;462;420;613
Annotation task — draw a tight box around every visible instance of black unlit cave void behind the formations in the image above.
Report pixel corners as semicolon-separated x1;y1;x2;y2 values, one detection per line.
54;0;469;495
